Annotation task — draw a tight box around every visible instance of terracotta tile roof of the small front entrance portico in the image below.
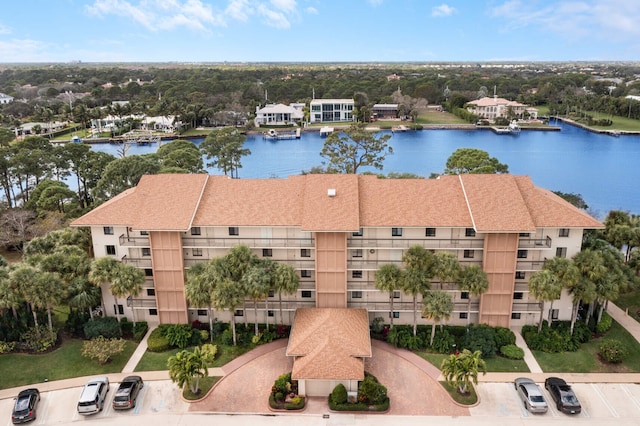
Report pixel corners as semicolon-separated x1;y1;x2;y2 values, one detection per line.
286;308;371;380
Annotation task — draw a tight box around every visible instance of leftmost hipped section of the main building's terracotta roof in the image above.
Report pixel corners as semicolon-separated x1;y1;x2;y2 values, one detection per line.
71;174;209;231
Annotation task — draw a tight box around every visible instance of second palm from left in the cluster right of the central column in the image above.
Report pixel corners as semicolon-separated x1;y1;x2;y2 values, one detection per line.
401;246;434;336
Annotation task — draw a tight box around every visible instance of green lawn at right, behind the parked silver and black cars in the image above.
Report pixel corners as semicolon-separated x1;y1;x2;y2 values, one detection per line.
532;321;640;373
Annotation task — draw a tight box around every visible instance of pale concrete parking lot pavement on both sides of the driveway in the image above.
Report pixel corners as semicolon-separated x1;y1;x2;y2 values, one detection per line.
0;380;640;425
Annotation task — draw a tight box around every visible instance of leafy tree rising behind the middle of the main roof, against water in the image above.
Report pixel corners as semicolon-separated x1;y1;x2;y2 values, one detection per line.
320;123;393;174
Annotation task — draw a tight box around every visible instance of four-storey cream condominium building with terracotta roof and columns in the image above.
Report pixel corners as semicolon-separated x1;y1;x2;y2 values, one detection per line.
72;174;602;326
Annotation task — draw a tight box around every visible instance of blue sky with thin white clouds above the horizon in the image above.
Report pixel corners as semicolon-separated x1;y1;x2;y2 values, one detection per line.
0;0;640;63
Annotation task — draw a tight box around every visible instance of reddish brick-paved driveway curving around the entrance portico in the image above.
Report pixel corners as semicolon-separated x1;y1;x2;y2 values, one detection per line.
189;339;470;416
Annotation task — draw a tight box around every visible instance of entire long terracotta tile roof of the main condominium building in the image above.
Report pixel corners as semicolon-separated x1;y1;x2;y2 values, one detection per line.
72;174;602;232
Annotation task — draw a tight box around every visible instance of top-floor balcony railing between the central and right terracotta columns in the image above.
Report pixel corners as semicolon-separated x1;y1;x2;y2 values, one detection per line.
347;237;484;250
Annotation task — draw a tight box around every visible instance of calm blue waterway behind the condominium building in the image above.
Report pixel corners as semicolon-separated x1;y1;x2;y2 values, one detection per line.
94;123;640;219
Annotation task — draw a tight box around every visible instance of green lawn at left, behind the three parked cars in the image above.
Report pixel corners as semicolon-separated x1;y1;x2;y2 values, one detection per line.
0;339;137;389
